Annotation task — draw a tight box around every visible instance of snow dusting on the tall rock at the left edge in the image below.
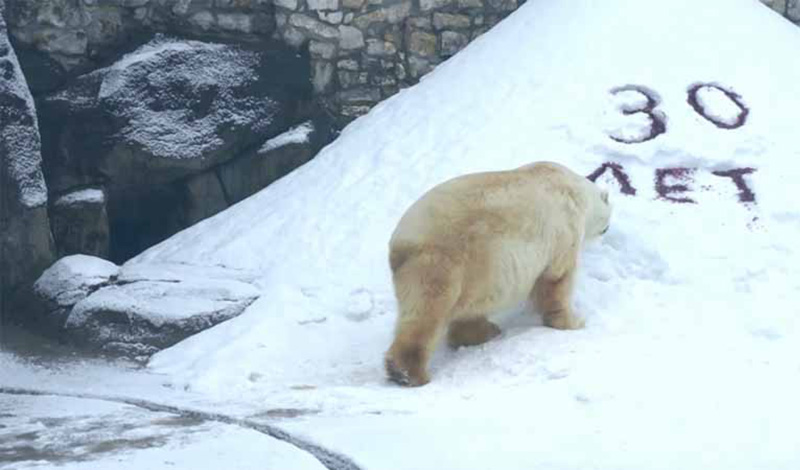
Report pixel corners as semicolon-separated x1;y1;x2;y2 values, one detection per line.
0;10;47;208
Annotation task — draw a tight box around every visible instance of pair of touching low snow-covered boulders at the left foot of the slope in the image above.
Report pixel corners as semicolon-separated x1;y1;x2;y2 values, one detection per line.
32;255;259;360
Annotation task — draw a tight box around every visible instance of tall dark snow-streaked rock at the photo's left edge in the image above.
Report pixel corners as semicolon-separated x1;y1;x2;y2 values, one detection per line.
0;0;54;316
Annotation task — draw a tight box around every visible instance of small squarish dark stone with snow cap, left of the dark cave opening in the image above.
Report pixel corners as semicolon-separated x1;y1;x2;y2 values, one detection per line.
50;188;109;258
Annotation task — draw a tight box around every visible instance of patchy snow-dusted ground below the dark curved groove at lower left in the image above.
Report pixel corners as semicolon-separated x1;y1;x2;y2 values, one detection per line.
0;393;326;470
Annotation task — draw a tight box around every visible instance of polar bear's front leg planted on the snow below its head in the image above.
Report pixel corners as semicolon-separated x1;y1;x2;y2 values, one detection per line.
533;270;585;330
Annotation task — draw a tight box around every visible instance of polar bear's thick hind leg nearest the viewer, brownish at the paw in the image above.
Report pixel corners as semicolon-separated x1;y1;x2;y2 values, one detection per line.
386;249;463;385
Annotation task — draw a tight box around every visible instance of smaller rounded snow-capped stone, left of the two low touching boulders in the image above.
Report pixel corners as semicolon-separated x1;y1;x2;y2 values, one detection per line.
33;255;119;334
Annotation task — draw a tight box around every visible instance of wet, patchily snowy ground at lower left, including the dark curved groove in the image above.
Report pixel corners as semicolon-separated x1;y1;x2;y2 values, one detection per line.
0;325;357;470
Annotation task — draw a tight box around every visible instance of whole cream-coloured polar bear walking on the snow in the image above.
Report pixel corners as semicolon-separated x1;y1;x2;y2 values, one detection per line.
385;162;611;386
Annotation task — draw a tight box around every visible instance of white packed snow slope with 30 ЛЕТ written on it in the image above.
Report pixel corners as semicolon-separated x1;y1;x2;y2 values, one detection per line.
131;0;800;470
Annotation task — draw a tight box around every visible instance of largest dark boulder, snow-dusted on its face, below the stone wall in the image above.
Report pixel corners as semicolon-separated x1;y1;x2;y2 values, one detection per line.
42;37;311;191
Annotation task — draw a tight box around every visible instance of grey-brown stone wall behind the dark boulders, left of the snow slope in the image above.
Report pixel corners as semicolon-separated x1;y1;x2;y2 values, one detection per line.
3;0;518;123
